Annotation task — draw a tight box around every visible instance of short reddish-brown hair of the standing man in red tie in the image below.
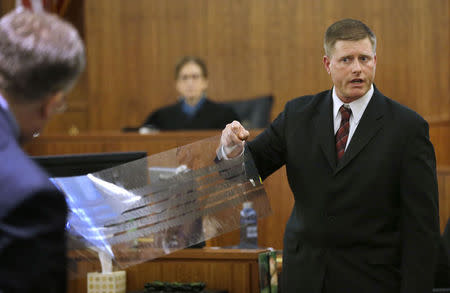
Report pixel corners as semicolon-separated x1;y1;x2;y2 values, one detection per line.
324;18;377;56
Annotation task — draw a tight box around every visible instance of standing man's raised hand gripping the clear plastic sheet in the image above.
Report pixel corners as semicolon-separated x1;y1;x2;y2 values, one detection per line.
220;120;250;158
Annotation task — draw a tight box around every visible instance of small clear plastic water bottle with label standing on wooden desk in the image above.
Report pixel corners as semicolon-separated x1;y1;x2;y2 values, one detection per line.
239;201;258;248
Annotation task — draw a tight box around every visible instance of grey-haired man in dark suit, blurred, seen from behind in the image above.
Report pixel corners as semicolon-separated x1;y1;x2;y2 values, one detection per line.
0;10;85;293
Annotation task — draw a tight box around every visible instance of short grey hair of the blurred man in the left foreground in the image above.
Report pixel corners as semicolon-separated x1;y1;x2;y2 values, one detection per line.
0;10;85;102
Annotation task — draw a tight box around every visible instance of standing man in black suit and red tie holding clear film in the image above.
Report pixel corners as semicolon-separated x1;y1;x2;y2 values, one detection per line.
218;19;439;293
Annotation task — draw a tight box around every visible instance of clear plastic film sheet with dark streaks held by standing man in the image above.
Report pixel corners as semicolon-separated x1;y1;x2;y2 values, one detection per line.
52;137;270;276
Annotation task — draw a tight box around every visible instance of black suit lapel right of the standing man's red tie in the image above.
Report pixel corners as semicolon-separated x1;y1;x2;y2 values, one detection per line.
334;89;384;174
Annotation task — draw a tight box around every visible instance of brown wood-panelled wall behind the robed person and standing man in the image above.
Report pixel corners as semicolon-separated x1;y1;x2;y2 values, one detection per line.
85;0;450;130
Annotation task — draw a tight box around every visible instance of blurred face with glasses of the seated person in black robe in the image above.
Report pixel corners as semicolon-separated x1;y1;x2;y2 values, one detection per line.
176;62;208;100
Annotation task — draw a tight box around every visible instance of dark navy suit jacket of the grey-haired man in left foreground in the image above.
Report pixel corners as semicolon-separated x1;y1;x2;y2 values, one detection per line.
0;108;67;293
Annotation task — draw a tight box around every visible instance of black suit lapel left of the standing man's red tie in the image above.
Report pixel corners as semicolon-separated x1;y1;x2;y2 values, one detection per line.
314;91;336;169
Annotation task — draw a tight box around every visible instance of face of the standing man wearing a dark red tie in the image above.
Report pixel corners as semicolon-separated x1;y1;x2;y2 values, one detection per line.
323;38;377;103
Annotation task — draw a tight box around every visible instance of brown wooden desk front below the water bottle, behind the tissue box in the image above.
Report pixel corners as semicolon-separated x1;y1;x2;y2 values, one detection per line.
68;247;266;293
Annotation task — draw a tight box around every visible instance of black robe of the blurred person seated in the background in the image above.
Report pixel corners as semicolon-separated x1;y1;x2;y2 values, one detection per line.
143;99;239;130
